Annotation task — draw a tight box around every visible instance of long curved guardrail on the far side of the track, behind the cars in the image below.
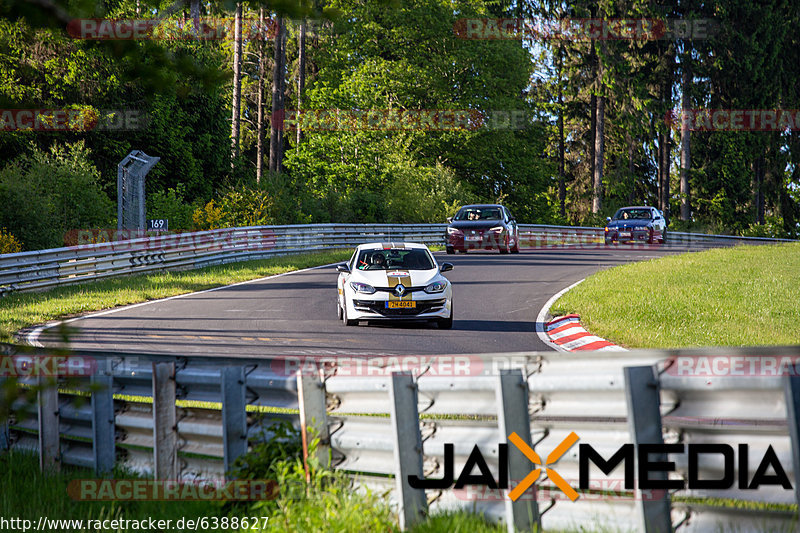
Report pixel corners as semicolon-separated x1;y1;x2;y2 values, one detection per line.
0;220;779;296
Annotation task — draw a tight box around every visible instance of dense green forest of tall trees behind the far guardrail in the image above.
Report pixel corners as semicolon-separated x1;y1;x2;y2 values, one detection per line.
0;0;800;253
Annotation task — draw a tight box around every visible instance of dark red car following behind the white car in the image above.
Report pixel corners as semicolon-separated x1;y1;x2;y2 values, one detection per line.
446;204;519;254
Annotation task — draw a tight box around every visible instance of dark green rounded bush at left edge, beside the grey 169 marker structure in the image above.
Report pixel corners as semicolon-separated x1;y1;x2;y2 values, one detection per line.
0;141;114;250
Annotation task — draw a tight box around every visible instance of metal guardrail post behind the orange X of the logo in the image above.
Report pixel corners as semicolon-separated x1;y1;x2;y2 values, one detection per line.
497;368;542;533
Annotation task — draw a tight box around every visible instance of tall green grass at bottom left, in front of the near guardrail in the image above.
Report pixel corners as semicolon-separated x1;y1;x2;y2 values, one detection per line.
0;452;505;533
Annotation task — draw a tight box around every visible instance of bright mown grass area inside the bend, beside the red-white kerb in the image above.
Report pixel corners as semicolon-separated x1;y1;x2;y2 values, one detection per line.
551;243;800;348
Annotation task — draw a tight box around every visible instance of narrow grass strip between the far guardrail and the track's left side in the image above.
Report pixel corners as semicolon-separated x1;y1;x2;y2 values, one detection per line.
0;250;353;342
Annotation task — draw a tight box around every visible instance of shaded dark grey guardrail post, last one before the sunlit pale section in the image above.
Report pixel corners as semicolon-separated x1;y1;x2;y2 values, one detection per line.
220;366;247;477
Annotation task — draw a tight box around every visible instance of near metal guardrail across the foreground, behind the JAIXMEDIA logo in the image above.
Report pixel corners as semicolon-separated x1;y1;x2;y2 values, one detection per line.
0;346;800;531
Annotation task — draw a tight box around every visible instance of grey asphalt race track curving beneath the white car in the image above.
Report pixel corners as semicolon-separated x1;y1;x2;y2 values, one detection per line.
39;245;686;357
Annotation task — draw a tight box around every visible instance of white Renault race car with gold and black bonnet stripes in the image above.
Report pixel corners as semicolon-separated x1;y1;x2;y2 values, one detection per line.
336;242;453;329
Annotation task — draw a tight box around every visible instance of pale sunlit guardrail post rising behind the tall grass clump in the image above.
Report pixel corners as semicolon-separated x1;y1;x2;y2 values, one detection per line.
297;368;330;474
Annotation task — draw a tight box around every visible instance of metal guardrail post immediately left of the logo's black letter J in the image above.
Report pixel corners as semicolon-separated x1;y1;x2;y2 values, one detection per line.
389;372;428;530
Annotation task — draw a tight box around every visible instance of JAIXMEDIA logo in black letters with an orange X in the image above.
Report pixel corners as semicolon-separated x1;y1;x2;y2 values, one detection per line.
408;432;792;501
